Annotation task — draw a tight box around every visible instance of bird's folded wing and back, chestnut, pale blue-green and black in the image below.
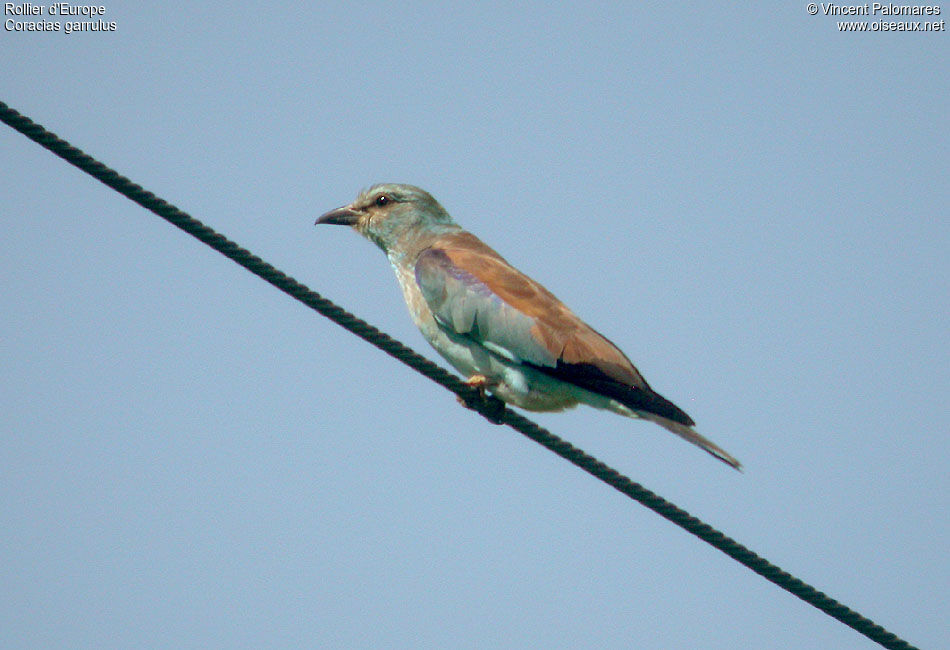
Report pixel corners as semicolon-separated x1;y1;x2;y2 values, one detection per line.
415;233;693;426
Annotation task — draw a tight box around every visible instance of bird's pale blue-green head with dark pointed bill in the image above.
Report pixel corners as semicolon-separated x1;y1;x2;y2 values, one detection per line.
317;183;458;255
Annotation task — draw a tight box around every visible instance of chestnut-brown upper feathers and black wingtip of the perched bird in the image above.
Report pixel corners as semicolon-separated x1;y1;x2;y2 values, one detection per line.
433;232;693;426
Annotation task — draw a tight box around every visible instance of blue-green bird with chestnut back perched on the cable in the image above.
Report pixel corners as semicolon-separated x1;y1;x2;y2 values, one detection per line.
315;183;741;469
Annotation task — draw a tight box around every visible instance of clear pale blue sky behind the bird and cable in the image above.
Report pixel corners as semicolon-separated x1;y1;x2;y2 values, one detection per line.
0;2;950;649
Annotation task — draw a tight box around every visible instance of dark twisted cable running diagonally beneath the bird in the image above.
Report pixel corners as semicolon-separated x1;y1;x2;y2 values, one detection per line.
0;102;914;650
